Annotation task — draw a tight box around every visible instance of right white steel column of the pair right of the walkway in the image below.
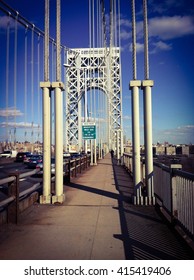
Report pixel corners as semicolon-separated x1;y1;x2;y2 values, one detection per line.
142;80;154;205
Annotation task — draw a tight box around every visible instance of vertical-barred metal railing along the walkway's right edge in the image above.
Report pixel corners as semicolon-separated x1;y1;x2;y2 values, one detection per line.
123;153;194;241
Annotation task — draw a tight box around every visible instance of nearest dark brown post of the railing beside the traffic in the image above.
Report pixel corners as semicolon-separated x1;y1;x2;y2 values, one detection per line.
7;171;20;224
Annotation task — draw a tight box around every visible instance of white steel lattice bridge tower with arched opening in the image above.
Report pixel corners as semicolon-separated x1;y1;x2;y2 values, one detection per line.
66;47;123;154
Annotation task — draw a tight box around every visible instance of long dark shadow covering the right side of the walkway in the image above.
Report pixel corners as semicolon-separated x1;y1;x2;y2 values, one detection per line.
112;159;194;260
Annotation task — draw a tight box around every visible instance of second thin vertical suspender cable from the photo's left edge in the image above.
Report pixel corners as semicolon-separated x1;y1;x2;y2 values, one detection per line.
14;12;19;146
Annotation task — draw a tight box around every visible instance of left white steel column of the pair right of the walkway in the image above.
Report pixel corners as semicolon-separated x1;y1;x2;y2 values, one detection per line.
130;80;143;204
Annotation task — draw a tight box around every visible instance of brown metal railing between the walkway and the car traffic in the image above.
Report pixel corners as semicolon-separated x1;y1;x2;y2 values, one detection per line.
0;156;90;224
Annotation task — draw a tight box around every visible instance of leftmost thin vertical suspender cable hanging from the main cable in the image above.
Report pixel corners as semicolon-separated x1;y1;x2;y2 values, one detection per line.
6;13;10;142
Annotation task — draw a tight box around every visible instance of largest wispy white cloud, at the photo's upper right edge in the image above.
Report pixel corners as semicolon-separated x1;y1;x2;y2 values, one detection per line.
149;16;194;40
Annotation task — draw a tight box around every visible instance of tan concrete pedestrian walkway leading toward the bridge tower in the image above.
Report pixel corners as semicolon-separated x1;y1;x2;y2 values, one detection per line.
0;155;194;260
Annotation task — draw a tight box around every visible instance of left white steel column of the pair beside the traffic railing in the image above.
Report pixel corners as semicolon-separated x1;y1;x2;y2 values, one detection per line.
40;82;51;204
